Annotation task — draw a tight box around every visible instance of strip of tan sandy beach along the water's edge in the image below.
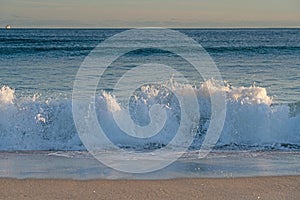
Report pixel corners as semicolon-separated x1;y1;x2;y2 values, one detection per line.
0;176;300;200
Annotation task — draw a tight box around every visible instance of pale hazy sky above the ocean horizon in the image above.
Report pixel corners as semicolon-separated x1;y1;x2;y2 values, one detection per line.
0;0;300;28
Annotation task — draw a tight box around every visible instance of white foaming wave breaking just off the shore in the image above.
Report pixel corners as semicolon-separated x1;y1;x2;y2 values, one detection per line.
0;81;300;150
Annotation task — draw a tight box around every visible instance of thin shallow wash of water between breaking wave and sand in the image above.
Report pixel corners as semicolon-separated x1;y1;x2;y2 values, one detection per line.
0;151;300;180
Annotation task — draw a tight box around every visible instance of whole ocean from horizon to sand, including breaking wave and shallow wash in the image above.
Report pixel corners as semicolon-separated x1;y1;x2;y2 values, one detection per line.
0;28;300;179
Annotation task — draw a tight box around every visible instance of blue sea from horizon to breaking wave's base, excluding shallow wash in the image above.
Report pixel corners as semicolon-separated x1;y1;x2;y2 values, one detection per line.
0;29;300;150
